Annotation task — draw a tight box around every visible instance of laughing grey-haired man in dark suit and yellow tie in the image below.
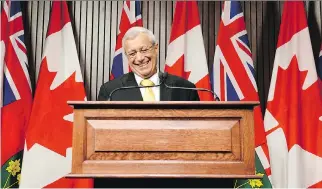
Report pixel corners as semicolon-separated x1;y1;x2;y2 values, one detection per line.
98;27;199;101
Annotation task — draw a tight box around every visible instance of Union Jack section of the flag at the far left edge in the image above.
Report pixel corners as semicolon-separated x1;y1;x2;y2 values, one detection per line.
1;1;31;106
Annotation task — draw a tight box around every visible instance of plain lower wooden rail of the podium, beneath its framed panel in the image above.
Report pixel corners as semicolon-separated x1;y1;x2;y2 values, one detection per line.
82;160;255;176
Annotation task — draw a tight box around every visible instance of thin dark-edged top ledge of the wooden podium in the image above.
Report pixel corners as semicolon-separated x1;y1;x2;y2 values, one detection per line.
67;101;260;109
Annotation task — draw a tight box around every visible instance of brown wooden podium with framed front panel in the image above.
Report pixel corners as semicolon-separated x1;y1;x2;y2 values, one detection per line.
68;101;259;178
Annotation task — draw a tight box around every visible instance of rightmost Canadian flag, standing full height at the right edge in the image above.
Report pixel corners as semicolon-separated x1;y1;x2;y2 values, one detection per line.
264;1;322;188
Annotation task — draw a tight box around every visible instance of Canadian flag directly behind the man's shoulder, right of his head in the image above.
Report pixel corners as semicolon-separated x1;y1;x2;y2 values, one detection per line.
165;1;214;101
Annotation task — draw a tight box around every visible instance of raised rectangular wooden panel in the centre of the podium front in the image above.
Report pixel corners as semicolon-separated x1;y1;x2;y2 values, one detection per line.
88;118;238;151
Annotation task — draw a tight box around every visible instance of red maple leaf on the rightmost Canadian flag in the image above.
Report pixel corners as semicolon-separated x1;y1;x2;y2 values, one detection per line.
267;56;322;157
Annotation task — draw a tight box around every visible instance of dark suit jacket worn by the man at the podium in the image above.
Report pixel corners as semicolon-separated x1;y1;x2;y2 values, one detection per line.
98;72;199;101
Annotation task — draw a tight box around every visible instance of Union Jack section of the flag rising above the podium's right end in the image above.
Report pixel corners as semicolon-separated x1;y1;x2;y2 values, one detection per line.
212;1;258;101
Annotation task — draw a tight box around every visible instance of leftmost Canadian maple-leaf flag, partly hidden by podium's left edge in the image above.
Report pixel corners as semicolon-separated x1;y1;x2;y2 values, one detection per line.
20;1;93;188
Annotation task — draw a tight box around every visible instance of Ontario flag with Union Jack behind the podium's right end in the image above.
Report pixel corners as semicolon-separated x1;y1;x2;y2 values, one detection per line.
212;1;272;188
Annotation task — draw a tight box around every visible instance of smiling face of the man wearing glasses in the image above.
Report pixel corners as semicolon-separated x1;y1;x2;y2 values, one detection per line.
124;33;158;78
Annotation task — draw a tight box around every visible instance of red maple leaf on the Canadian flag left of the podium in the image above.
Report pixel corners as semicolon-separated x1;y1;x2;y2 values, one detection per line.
26;57;85;156
